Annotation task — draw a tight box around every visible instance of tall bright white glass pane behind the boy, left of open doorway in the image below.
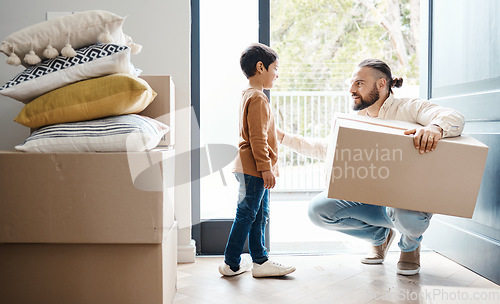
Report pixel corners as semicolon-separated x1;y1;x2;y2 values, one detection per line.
200;0;259;219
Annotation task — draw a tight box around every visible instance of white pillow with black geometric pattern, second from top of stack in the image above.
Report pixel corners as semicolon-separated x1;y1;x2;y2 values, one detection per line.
0;44;138;103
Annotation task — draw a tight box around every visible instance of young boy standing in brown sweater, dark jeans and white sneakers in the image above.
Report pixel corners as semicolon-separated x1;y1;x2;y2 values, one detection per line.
219;44;295;277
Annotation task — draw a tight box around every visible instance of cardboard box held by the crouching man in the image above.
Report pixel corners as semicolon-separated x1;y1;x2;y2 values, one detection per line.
328;115;488;218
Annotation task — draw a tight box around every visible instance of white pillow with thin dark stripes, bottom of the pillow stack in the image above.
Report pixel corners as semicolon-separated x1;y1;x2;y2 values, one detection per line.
16;114;169;153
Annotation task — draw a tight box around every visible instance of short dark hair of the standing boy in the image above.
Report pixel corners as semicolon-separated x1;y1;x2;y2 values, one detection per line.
240;43;278;78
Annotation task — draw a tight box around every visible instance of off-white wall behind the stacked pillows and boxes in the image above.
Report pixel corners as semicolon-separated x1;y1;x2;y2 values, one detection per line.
0;0;193;261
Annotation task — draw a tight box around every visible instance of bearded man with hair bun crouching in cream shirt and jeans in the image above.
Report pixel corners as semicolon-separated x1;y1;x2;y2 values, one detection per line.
277;59;464;275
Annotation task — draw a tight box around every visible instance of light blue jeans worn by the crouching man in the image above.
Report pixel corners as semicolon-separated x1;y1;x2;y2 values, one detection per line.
309;191;432;252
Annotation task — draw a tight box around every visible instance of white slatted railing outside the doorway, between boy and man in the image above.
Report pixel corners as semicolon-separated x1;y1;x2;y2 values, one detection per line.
271;91;350;191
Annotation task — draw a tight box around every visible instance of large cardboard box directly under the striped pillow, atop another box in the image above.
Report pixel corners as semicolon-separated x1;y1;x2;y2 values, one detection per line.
0;151;175;244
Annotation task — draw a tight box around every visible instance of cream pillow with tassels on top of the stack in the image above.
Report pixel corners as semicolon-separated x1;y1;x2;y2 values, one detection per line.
0;10;140;67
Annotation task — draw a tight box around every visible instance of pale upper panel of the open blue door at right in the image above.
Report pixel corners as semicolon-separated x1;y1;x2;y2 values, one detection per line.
432;0;500;97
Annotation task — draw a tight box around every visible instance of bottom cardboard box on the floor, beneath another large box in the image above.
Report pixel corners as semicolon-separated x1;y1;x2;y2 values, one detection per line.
0;223;177;304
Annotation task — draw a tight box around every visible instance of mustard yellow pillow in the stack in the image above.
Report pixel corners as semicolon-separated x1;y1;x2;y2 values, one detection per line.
14;74;156;128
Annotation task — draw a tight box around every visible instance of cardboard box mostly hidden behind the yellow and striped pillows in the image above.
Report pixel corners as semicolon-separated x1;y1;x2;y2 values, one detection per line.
139;75;175;147
